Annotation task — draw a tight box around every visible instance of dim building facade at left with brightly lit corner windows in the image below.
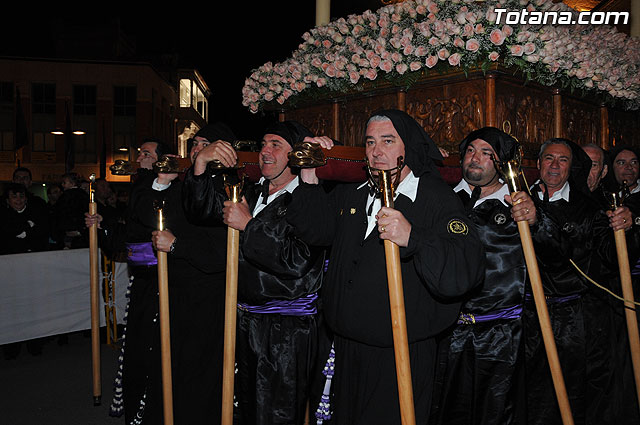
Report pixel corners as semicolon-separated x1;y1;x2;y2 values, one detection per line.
0;58;210;184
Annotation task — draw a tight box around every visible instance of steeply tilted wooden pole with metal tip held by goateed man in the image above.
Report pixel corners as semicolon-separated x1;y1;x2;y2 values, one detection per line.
502;162;573;425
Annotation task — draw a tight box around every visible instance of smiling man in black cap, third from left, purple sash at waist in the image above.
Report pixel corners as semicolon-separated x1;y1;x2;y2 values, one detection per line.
183;121;324;425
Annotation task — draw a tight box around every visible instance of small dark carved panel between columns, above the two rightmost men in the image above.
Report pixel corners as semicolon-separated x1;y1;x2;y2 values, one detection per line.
562;95;600;145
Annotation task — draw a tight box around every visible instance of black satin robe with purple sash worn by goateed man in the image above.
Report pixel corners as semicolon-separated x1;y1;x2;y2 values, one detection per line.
430;190;544;425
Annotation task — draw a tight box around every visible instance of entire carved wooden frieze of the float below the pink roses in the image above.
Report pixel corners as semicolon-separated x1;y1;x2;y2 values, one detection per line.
284;73;640;157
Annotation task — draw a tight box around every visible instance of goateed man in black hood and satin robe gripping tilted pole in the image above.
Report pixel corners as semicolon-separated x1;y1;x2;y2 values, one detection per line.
432;127;540;425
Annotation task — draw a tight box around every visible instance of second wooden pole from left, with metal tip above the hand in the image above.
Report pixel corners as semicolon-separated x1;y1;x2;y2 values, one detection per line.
156;205;173;425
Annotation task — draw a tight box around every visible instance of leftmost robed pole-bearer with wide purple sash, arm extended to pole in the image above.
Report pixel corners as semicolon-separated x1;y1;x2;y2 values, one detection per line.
85;139;177;425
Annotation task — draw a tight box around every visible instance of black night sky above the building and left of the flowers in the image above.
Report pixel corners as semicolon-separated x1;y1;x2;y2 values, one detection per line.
0;0;379;140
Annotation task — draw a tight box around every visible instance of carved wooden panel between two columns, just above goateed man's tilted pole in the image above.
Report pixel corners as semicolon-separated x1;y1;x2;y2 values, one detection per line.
496;78;553;158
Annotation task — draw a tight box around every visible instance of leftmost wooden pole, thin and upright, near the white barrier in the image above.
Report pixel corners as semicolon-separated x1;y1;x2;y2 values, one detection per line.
89;174;102;406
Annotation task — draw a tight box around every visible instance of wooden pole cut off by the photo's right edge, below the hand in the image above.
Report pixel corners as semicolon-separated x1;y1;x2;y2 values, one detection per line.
614;229;640;404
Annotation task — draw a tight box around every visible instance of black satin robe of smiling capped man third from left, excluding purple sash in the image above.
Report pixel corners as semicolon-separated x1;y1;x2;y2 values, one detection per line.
183;169;324;425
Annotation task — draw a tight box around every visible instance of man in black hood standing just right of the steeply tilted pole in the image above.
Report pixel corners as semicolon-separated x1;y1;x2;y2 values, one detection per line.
524;139;633;425
